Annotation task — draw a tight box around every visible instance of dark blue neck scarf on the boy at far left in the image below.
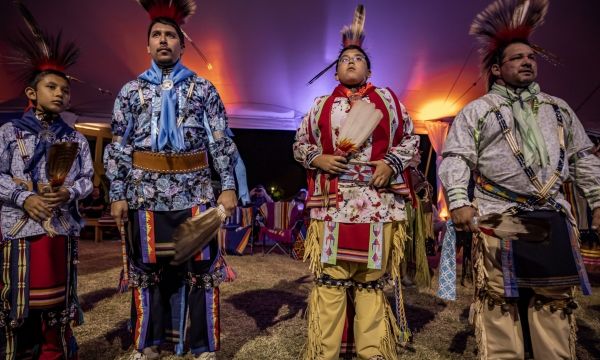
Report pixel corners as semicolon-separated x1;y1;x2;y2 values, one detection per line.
11;109;75;184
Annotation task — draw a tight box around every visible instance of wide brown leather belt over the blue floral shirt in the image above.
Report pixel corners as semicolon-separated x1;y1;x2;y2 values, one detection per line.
133;151;208;174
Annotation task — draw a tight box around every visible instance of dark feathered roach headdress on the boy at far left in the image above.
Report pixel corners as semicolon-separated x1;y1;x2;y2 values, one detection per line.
4;0;79;83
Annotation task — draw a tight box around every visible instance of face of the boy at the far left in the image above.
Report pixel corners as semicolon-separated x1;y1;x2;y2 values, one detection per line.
25;74;71;114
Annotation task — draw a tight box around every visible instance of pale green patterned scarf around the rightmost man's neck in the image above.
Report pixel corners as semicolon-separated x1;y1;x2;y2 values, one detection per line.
490;82;550;168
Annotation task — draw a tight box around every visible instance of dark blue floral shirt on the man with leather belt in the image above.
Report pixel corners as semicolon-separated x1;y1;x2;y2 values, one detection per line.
104;76;238;211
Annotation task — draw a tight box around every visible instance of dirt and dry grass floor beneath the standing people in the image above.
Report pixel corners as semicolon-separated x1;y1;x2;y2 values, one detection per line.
75;241;600;360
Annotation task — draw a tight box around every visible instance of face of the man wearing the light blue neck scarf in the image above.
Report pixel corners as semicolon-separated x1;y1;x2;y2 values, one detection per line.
148;23;183;65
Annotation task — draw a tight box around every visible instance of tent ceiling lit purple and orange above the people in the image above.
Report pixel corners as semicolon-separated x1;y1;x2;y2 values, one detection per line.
0;0;600;129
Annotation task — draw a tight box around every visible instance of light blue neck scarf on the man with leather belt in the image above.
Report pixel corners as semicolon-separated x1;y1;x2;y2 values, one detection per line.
138;61;194;151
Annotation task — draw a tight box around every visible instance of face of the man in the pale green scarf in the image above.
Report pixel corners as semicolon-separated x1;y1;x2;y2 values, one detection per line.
492;43;537;88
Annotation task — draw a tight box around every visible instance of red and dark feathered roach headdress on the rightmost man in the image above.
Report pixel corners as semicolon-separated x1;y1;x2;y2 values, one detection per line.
469;0;549;77
